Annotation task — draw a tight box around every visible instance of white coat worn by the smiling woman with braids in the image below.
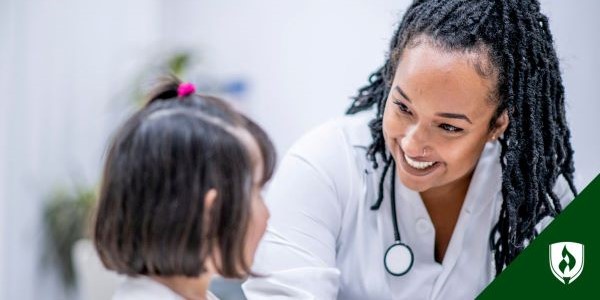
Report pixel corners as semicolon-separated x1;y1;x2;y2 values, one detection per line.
243;112;573;300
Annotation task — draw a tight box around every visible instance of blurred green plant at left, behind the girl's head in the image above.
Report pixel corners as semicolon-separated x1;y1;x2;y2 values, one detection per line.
43;186;96;287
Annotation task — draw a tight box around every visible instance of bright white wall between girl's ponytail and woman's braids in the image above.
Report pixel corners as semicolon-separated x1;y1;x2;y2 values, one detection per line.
163;0;409;154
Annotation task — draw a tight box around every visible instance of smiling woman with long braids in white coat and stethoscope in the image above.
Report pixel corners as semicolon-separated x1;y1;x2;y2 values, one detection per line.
244;0;575;299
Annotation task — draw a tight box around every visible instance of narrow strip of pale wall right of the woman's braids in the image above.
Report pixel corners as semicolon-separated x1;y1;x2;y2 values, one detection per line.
542;0;600;190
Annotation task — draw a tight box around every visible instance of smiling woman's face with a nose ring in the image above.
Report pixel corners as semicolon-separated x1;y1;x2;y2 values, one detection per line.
383;42;508;192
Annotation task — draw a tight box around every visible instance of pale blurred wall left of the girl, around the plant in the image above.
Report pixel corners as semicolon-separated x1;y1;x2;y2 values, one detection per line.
0;0;159;299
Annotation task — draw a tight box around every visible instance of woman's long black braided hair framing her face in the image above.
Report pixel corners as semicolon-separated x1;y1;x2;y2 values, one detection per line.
347;0;577;274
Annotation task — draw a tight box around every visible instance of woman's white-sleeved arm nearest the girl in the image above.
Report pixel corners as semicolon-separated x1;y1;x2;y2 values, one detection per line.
243;120;348;299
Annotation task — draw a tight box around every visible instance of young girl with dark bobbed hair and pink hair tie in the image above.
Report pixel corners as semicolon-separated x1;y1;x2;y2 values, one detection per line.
94;79;275;300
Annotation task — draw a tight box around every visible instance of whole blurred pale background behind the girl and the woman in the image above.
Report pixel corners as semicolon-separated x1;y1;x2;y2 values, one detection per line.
0;0;600;299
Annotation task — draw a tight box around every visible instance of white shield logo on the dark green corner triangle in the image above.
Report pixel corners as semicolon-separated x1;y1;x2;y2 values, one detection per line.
549;242;584;284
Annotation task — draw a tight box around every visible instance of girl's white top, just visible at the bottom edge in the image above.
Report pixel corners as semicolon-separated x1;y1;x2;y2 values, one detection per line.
112;276;219;300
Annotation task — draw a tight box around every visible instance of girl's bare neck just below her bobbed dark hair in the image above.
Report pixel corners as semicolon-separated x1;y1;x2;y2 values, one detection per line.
152;272;212;300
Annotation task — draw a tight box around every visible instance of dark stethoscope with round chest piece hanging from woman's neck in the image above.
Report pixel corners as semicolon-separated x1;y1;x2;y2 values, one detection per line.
371;156;415;276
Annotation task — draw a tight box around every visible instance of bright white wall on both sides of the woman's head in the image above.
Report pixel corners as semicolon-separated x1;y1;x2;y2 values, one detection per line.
162;0;600;189
